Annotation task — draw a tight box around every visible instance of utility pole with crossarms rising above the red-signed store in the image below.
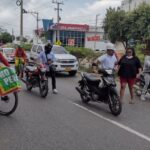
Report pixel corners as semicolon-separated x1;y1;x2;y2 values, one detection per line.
52;0;64;41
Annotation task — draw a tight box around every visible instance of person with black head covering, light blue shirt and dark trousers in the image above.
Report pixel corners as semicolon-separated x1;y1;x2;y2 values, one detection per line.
39;43;58;94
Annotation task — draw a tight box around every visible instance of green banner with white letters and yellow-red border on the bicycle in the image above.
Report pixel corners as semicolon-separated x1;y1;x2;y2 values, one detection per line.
0;67;21;96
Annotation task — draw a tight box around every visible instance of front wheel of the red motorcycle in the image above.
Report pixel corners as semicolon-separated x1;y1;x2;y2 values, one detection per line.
40;80;48;98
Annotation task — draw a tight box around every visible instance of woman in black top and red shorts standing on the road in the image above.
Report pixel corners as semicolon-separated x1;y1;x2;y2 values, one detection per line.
118;48;141;104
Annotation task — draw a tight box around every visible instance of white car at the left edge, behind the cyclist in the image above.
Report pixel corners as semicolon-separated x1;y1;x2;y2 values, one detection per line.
0;47;15;63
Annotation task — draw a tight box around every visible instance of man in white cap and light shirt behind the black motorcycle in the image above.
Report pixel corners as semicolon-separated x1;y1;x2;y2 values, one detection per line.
97;43;118;69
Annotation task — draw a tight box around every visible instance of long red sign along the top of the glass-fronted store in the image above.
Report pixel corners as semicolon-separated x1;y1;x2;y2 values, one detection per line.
53;23;89;31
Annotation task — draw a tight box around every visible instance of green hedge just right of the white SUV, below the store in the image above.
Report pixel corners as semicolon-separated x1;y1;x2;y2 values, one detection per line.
65;46;101;59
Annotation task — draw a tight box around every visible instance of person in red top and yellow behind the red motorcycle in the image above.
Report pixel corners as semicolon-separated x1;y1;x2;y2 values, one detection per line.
15;45;27;78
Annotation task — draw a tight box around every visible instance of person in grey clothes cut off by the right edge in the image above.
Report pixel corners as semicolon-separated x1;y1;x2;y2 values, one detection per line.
141;56;150;101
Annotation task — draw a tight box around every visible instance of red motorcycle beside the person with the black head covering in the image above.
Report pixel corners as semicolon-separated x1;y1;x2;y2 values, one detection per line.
24;63;48;98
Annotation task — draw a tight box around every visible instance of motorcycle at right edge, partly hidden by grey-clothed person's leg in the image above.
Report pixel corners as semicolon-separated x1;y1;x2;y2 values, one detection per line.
134;74;150;96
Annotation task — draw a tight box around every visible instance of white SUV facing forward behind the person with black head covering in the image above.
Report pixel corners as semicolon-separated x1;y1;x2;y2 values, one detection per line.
30;44;79;76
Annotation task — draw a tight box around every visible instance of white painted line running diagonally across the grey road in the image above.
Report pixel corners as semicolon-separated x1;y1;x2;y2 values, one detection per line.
73;103;150;142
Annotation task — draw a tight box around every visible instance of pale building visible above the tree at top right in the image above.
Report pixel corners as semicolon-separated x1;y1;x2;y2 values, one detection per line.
121;0;150;11
